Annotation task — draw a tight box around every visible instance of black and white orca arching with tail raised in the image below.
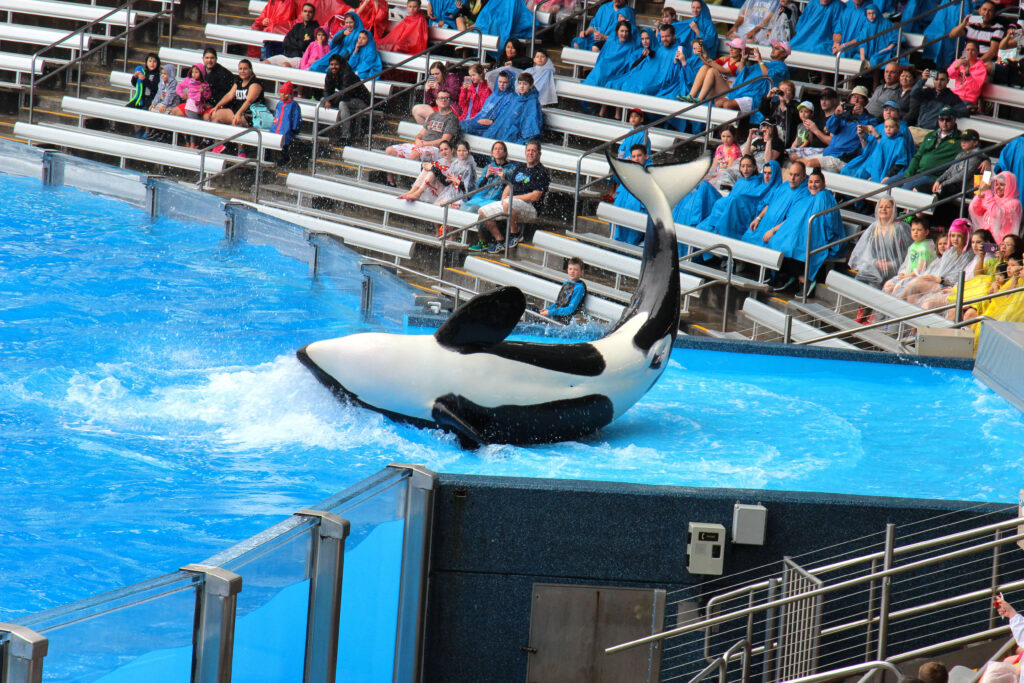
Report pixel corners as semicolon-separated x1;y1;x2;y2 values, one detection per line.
296;153;710;449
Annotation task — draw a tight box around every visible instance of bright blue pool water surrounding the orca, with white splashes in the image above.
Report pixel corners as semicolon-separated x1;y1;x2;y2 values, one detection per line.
0;176;1024;621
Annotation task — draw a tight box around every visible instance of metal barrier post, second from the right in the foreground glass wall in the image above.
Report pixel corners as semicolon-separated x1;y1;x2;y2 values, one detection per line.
295;510;350;683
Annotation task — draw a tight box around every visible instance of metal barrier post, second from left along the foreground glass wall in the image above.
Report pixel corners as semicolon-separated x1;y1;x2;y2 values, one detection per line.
181;564;242;683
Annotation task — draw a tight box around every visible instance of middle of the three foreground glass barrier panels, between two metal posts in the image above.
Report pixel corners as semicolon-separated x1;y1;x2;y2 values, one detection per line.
221;517;316;683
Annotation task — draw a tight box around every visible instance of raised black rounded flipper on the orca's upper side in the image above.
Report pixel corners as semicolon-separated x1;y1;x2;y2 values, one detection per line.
434;287;526;350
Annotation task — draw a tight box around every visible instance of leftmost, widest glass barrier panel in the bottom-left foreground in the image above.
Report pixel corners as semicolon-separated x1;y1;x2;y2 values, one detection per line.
18;572;197;683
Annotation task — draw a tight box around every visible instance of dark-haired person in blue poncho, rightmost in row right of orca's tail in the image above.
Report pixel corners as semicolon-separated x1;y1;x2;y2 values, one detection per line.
766;171;846;294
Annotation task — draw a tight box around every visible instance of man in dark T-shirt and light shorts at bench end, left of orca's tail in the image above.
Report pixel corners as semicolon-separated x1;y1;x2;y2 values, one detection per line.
469;140;551;254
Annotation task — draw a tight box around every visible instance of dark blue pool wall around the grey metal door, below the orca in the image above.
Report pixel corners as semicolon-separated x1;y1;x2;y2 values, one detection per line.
425;474;1014;683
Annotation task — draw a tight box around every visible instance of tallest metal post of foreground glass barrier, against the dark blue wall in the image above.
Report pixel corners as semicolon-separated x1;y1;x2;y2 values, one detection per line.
388;463;437;682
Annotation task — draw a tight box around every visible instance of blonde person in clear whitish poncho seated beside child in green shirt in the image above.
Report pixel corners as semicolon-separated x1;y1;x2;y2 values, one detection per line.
847;195;913;289
